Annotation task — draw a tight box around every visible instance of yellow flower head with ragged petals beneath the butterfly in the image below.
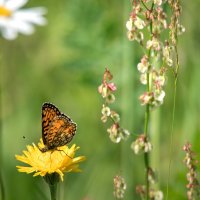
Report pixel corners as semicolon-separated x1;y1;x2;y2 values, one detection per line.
15;139;86;181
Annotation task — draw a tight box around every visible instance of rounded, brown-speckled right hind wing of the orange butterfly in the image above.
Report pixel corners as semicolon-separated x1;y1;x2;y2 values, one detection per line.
46;114;76;149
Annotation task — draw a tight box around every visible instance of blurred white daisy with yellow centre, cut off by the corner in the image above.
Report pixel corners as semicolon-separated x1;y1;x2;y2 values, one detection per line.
0;0;47;40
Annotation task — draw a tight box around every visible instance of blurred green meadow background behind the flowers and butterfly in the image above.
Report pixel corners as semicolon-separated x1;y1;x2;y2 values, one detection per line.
0;0;200;200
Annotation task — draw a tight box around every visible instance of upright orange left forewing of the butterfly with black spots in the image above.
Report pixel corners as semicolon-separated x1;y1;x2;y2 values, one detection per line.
42;103;61;145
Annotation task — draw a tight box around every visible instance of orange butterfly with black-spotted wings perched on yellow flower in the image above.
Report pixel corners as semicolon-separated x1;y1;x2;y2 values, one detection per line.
40;103;76;152
